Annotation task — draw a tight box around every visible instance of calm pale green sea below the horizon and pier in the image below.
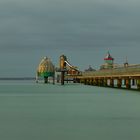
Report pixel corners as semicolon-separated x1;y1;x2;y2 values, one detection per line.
0;81;140;140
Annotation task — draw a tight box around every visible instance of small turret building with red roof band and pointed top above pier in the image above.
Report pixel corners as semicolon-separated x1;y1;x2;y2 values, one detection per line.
100;52;114;69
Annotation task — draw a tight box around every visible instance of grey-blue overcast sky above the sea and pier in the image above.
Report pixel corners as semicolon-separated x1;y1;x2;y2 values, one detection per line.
0;0;140;77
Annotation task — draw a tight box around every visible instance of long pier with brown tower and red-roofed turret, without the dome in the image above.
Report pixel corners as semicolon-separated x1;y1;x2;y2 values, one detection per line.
60;52;140;90
